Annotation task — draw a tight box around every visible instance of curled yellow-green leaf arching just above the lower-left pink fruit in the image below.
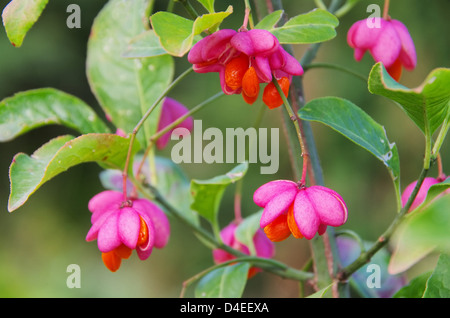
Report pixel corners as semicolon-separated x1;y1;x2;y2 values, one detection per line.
8;134;137;212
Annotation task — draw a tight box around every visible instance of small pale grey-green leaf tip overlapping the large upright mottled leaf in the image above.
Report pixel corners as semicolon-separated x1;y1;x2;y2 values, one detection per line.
122;30;167;58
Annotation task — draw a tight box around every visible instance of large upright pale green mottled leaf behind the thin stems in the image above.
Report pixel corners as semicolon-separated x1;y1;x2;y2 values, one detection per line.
87;0;174;147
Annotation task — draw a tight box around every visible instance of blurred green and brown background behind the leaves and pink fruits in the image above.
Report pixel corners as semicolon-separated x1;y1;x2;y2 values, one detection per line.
0;0;450;297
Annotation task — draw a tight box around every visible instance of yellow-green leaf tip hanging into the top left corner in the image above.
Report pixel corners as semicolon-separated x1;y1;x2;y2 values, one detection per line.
2;0;48;47
